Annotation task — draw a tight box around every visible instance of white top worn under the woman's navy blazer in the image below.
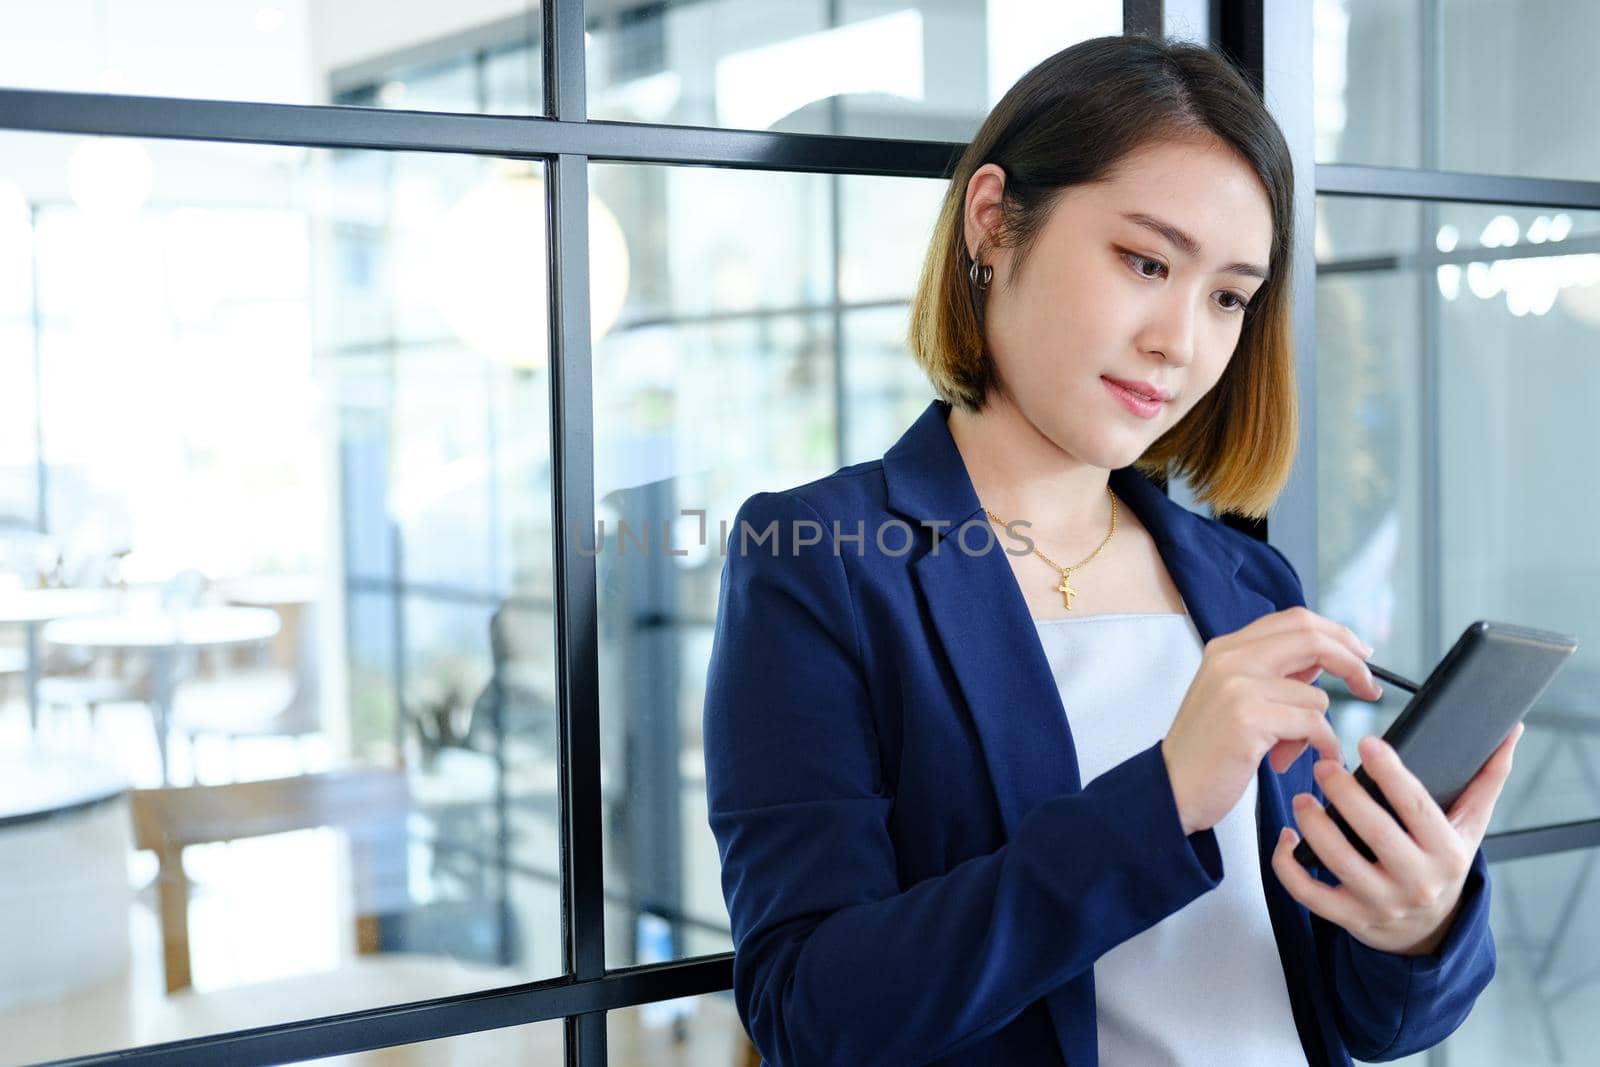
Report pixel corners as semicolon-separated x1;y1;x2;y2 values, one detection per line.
1034;614;1306;1067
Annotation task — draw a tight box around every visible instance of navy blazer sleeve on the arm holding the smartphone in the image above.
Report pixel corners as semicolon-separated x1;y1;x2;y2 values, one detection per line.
1267;544;1494;1062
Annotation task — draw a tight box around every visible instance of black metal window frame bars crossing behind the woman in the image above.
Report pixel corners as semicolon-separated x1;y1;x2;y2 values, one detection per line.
0;0;1600;1067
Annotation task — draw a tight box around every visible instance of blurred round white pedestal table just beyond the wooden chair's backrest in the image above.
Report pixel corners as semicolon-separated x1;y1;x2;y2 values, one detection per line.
43;606;282;785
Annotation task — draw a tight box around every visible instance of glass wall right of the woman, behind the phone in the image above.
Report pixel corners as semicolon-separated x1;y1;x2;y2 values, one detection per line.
1315;0;1600;1064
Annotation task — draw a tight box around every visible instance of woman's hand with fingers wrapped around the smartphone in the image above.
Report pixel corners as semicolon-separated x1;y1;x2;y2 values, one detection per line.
1272;723;1522;955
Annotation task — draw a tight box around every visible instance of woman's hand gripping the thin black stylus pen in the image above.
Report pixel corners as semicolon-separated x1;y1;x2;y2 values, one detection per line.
1162;608;1382;833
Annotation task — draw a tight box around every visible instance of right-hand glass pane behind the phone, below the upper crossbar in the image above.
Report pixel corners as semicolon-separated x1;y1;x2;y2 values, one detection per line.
1317;194;1600;832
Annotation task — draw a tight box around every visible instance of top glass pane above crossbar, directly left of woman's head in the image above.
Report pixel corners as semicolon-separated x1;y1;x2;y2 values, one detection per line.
587;0;1122;141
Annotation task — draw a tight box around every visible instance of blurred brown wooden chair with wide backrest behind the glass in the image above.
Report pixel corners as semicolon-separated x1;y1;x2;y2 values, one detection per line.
128;769;411;993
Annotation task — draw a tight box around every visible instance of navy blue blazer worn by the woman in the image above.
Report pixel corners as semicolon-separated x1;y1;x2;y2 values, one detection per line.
704;400;1494;1067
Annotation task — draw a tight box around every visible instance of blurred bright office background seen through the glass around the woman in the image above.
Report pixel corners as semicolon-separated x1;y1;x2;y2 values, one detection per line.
0;0;1600;1064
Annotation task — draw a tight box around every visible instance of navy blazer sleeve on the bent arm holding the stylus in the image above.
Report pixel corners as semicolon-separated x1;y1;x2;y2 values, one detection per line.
704;493;1222;1067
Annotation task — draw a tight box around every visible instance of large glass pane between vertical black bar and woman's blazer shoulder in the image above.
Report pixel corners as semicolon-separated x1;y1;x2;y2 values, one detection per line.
598;166;942;966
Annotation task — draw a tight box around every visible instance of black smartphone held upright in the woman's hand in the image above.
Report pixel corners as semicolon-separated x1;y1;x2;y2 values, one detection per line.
1294;619;1578;867
